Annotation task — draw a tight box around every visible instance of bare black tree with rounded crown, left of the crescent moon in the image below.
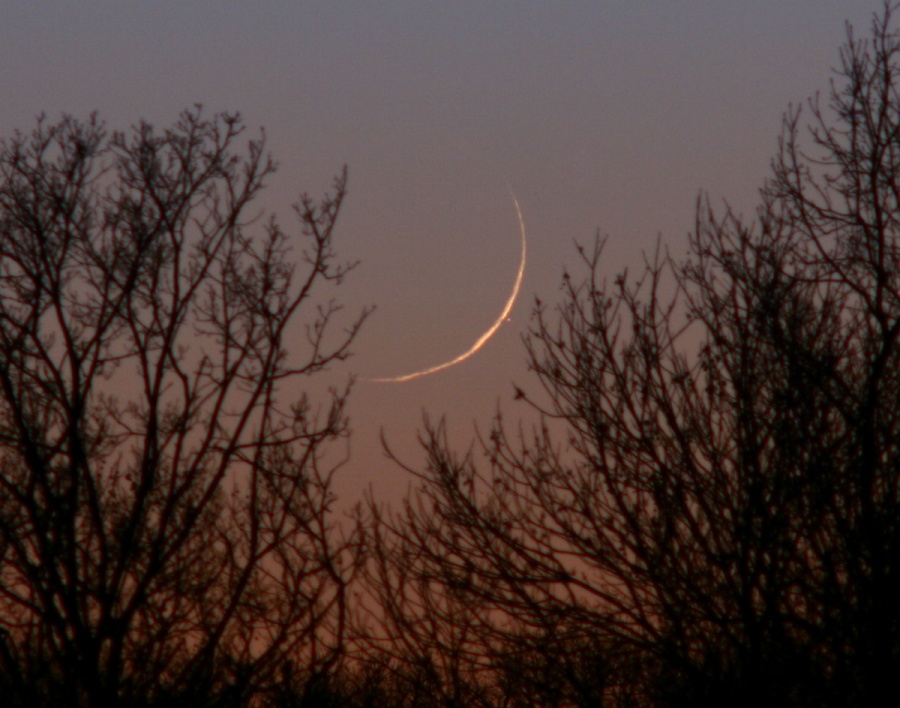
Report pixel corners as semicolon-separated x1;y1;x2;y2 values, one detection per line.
0;108;365;706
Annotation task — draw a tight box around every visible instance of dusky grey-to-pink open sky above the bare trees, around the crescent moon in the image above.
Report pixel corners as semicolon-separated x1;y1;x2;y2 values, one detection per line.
0;0;881;502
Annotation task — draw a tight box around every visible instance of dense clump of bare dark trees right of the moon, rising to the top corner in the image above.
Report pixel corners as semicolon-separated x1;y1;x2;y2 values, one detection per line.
369;5;900;706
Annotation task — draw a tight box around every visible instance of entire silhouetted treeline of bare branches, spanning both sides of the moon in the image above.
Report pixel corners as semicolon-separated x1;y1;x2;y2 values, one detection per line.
0;4;900;708
